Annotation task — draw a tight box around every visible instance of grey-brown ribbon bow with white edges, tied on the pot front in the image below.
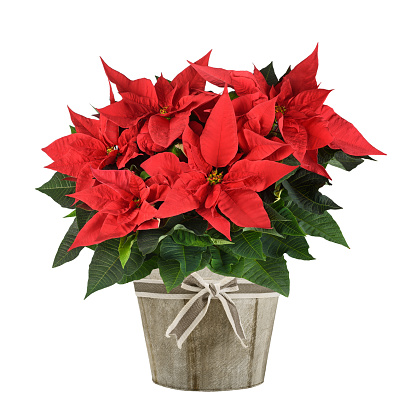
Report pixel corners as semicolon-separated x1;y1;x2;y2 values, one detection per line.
166;273;247;348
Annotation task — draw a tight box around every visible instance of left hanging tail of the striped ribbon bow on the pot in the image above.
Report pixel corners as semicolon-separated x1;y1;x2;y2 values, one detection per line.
166;289;211;349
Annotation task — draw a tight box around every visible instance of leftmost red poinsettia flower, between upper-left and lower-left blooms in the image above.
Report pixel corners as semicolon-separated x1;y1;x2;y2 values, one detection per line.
42;109;139;191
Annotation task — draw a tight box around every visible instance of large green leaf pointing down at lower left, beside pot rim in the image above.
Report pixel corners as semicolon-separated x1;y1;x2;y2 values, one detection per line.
85;238;124;299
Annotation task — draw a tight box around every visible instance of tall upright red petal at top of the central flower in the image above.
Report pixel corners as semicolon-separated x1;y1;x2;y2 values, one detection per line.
200;87;238;167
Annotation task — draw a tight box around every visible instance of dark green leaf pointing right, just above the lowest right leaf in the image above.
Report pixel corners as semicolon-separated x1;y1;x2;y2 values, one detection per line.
261;234;314;260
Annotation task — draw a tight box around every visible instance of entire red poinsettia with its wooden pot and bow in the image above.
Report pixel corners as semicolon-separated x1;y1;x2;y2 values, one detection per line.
38;47;384;390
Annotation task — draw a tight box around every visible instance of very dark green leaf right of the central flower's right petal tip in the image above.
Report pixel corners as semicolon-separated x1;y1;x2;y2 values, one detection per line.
282;169;341;214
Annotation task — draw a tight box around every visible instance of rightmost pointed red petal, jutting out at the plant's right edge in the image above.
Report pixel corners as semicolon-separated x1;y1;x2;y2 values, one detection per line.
321;105;385;156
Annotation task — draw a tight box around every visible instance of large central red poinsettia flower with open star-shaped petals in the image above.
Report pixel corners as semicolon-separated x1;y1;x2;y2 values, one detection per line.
141;87;295;239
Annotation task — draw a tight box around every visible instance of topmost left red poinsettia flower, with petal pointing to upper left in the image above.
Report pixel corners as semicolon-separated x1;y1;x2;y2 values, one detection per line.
99;52;216;150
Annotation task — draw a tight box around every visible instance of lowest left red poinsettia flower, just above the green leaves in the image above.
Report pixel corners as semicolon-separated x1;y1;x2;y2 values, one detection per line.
70;169;168;250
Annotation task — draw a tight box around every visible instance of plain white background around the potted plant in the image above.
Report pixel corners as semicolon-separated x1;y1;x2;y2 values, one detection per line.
0;0;415;416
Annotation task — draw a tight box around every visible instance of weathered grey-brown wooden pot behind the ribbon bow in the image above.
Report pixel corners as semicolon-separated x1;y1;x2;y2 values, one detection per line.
134;269;278;391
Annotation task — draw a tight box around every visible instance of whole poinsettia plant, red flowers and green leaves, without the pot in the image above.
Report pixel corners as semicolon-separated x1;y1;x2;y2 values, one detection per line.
38;47;384;297
